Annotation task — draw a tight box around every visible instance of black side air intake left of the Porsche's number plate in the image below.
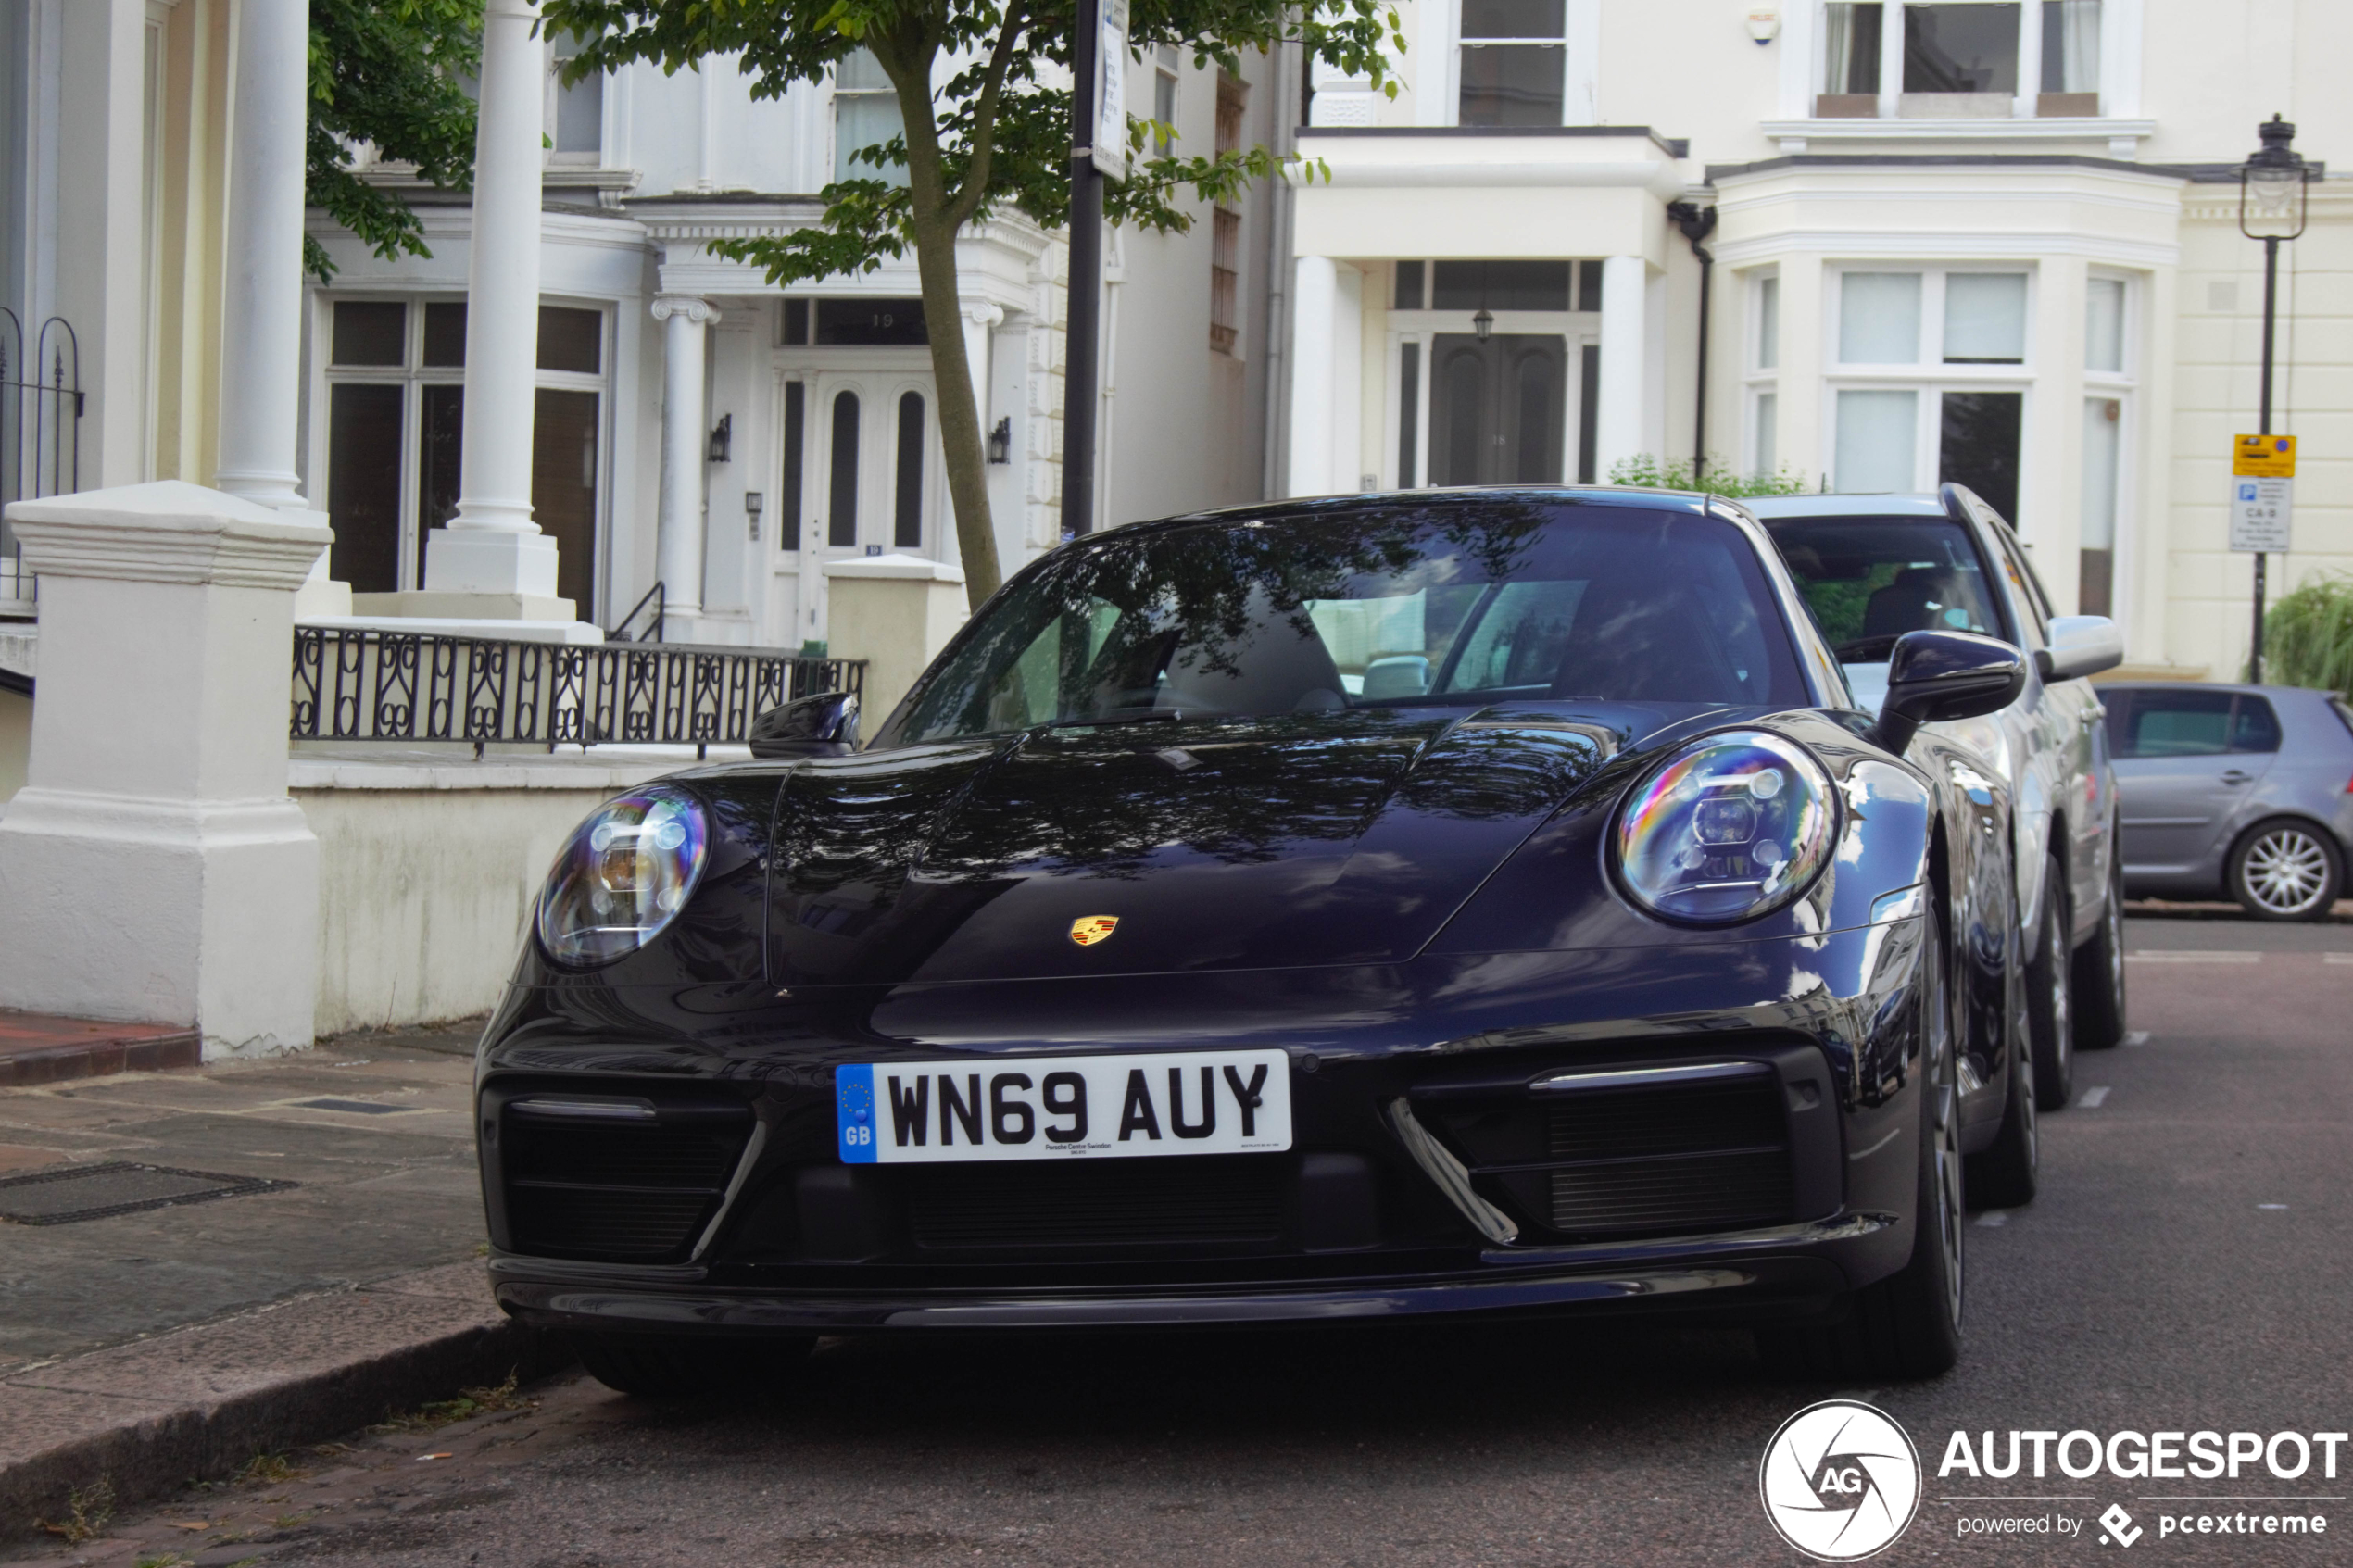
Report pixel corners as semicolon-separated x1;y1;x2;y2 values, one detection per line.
498;1100;753;1262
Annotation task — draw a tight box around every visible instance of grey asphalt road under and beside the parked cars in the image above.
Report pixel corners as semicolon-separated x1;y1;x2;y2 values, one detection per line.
27;917;2353;1568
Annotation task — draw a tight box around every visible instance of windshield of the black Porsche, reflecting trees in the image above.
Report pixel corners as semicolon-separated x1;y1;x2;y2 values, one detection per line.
889;501;1812;743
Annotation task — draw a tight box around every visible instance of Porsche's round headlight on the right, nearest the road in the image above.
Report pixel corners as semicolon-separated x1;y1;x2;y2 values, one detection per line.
1617;729;1835;924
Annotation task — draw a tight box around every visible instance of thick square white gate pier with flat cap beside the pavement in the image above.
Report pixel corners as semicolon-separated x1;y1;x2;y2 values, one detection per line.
0;480;327;1058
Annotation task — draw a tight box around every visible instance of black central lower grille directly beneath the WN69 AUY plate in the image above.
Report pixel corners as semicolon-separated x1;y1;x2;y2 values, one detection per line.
901;1157;1287;1250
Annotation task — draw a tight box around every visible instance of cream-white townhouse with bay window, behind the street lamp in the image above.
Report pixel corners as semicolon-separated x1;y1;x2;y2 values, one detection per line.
1285;0;2353;680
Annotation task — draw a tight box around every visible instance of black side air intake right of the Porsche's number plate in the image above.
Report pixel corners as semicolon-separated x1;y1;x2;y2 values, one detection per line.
1430;1065;1795;1241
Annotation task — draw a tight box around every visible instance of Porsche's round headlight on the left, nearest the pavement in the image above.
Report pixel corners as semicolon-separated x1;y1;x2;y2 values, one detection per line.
539;787;711;969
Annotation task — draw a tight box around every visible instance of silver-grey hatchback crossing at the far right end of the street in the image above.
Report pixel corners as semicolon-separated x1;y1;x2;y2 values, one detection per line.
2099;682;2353;919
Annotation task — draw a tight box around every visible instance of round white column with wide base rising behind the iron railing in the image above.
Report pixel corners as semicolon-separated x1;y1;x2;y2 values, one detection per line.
426;0;552;606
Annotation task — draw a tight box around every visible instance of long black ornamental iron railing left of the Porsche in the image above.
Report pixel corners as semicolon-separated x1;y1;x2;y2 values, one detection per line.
292;625;866;757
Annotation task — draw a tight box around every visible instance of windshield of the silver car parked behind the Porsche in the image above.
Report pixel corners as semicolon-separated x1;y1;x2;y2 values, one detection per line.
1765;517;2009;665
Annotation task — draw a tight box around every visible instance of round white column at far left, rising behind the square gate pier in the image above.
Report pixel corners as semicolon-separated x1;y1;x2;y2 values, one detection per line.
214;0;310;510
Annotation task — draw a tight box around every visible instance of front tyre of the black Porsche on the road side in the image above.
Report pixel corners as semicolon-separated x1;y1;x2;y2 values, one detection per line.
1757;917;1965;1380
